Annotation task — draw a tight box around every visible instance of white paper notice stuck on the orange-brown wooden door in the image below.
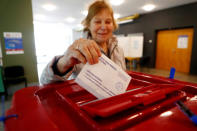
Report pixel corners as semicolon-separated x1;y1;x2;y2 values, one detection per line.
177;35;188;49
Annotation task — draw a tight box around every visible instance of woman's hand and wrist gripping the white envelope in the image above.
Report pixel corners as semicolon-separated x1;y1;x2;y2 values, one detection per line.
57;38;101;73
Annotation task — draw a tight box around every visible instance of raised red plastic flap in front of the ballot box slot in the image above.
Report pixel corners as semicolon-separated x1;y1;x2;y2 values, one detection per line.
81;85;185;117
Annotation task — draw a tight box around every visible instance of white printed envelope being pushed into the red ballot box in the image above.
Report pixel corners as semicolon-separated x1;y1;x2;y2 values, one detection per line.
75;55;131;99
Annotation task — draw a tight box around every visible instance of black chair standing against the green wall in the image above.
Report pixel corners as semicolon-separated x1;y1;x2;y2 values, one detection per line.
3;66;27;95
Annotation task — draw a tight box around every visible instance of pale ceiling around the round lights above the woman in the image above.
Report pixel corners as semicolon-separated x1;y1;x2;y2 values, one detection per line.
32;0;197;26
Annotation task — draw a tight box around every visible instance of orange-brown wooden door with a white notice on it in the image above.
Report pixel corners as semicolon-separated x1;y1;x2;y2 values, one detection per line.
156;28;194;73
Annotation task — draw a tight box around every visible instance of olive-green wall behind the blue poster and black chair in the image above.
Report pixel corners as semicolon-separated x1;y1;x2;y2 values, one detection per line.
0;0;38;83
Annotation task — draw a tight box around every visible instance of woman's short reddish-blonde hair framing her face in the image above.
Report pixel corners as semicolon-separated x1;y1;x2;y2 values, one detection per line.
82;0;118;33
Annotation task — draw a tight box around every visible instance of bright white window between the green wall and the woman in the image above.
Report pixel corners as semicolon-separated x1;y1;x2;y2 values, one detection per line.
34;22;72;81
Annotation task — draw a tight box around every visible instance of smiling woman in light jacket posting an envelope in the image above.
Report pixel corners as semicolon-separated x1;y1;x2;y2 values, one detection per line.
41;0;126;84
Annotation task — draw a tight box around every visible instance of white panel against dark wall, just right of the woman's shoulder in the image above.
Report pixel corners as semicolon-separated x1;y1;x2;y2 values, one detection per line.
117;33;144;58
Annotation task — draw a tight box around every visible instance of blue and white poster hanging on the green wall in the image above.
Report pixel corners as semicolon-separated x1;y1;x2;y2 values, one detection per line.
4;32;24;54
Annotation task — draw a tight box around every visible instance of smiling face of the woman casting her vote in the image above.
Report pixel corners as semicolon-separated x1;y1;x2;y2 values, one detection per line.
89;9;114;44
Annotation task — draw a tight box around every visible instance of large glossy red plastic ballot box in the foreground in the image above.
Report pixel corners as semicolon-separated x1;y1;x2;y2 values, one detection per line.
5;72;197;131
